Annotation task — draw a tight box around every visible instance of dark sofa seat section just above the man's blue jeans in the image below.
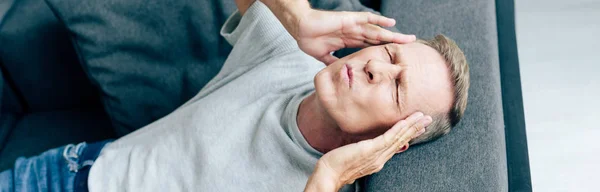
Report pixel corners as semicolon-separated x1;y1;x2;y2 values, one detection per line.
0;108;115;171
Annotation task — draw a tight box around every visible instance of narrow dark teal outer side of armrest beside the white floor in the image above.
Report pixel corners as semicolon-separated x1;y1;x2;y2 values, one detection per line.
496;0;532;191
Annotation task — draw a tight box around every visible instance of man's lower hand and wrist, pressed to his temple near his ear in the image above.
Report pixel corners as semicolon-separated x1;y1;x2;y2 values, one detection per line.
305;113;432;191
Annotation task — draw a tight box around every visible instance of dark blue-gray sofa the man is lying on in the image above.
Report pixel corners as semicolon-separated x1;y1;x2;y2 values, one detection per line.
0;0;531;191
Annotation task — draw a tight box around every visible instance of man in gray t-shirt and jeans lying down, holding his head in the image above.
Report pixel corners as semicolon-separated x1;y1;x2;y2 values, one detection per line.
0;0;469;191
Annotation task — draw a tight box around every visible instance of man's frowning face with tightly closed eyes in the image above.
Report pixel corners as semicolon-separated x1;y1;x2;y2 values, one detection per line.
315;43;453;135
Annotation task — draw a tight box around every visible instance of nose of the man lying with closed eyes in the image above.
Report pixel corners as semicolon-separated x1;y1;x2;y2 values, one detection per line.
364;60;402;84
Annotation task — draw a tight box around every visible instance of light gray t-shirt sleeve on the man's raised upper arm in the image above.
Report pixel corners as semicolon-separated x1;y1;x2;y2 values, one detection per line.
221;1;300;72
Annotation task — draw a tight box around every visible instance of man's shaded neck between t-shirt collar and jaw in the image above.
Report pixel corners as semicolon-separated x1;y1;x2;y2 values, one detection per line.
296;92;350;153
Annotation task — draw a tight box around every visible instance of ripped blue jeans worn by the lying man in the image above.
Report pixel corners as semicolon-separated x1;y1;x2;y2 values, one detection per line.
0;140;111;192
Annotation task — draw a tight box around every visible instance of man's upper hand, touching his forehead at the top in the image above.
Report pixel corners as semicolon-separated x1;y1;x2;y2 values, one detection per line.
292;9;416;65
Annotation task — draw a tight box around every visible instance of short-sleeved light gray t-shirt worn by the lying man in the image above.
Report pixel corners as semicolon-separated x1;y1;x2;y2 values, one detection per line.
88;1;352;192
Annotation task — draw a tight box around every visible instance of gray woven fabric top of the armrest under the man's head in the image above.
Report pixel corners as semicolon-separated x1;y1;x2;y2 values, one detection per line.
366;0;508;191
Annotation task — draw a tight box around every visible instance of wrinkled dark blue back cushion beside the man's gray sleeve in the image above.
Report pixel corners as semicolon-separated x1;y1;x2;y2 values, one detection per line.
47;0;235;135
